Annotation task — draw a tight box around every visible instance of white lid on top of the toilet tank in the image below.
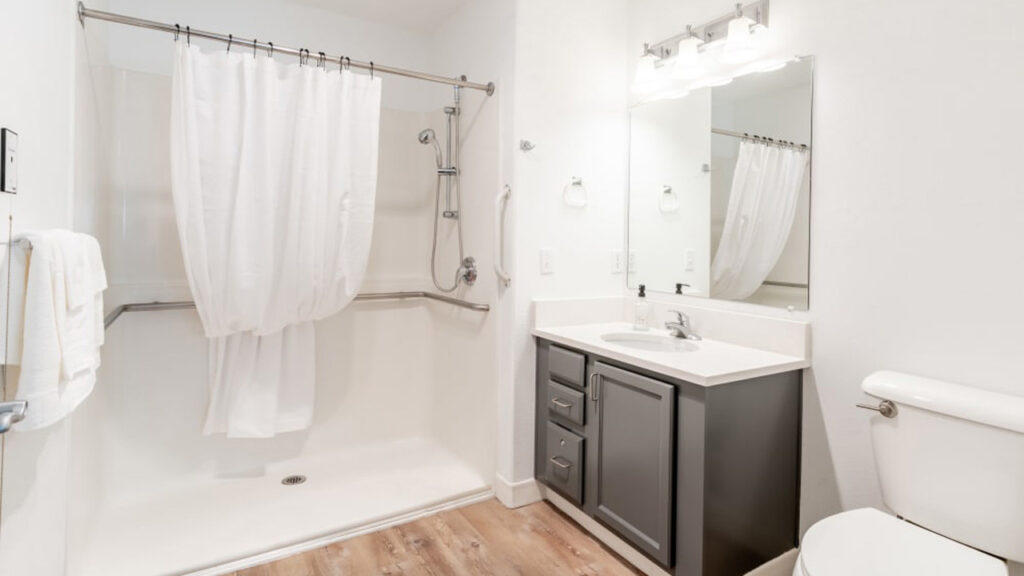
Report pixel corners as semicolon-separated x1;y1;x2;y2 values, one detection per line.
860;370;1024;434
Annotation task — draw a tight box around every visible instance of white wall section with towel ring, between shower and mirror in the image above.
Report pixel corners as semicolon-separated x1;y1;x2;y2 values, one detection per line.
499;0;631;483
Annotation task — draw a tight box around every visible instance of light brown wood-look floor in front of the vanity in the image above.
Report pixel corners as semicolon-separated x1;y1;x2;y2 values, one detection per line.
232;499;639;576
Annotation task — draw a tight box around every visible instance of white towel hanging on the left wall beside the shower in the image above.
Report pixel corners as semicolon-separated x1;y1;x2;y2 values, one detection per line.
12;231;106;431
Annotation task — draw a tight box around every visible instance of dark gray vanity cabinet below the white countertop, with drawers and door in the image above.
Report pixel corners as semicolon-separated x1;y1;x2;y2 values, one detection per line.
535;338;801;576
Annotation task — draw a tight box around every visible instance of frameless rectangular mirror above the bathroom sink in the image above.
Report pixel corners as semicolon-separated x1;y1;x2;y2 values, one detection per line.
628;57;813;310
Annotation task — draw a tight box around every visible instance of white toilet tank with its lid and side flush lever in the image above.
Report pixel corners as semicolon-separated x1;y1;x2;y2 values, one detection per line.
861;372;1024;562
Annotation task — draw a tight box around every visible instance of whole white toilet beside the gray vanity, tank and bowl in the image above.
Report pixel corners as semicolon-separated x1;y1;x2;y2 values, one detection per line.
793;372;1024;576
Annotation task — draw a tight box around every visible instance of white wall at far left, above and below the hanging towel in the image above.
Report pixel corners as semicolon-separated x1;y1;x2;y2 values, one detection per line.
0;0;83;576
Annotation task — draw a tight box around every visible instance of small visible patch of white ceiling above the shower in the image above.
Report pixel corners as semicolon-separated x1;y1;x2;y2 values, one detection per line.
289;0;470;32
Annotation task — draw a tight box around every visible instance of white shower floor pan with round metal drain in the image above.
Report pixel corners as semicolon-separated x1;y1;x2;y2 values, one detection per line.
69;439;490;576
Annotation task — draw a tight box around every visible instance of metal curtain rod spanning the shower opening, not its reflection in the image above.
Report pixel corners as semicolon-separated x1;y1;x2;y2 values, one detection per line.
78;2;495;96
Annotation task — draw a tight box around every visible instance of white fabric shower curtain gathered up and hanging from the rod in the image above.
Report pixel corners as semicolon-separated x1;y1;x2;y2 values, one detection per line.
171;42;381;438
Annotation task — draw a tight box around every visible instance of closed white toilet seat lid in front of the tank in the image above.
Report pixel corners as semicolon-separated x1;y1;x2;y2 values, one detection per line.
793;508;1007;576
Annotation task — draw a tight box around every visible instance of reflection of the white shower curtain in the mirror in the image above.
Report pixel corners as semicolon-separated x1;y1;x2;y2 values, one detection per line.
711;140;808;300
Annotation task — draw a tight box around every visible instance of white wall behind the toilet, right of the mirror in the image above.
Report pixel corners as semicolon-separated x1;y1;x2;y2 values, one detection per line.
633;0;1024;569
